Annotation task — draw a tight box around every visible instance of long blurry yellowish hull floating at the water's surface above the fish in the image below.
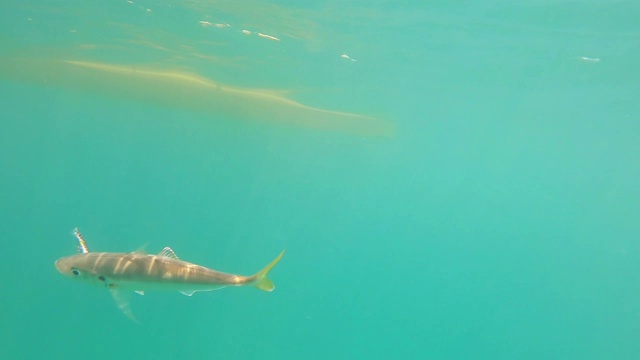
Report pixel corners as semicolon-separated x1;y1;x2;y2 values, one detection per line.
0;57;395;137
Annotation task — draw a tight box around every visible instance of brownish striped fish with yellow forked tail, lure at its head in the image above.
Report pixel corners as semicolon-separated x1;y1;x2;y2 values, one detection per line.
56;228;285;320
